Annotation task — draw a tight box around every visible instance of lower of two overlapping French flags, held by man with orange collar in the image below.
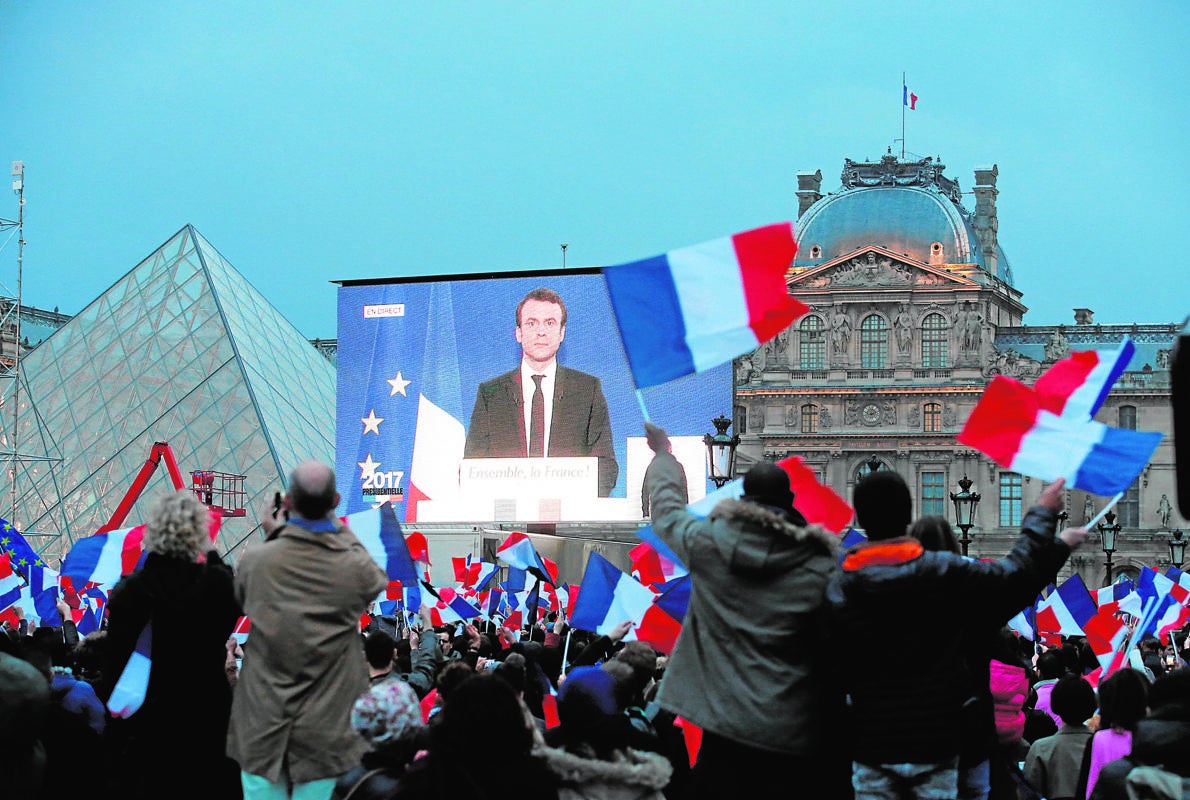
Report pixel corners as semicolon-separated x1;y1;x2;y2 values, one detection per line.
956;375;1161;496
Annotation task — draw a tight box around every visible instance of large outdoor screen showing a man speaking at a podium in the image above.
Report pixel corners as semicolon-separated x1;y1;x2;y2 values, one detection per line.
330;270;732;524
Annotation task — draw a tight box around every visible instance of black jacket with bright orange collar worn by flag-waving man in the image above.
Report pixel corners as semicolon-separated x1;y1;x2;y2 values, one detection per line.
829;506;1070;764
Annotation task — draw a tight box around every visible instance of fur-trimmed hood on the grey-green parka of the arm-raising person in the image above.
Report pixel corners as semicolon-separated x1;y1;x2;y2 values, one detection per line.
709;500;839;573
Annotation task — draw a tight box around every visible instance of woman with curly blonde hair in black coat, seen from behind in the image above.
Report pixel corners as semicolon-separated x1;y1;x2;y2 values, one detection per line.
100;492;240;798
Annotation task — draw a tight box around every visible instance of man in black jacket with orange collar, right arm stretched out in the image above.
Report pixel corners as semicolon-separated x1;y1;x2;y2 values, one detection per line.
827;470;1086;799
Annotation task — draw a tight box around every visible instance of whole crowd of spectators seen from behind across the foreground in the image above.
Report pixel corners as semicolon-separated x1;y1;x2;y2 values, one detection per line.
0;447;1190;800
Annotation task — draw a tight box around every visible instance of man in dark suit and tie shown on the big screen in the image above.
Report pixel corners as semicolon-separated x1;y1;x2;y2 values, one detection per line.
463;288;619;498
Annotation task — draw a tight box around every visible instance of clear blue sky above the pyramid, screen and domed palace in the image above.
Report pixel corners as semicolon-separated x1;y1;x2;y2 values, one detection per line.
0;0;1190;338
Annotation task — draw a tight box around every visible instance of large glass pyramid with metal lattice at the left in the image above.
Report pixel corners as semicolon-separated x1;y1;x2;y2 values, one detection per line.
0;225;336;567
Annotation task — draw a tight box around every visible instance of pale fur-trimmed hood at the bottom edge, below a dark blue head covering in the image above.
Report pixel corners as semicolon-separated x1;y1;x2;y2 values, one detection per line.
534;748;674;800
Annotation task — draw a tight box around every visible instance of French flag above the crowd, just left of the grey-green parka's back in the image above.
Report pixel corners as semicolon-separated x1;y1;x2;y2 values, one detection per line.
570;552;682;652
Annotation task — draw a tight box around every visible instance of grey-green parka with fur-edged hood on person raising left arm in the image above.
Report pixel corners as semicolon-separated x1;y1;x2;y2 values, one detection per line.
647;454;838;756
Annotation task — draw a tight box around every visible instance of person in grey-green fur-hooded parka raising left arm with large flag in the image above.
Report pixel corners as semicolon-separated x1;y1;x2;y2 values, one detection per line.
645;423;847;798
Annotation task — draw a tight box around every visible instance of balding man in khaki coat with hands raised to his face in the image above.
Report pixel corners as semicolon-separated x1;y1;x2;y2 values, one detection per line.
227;461;388;800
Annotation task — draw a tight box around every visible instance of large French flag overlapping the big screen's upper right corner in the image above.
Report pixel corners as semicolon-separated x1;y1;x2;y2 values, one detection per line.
603;223;809;389
